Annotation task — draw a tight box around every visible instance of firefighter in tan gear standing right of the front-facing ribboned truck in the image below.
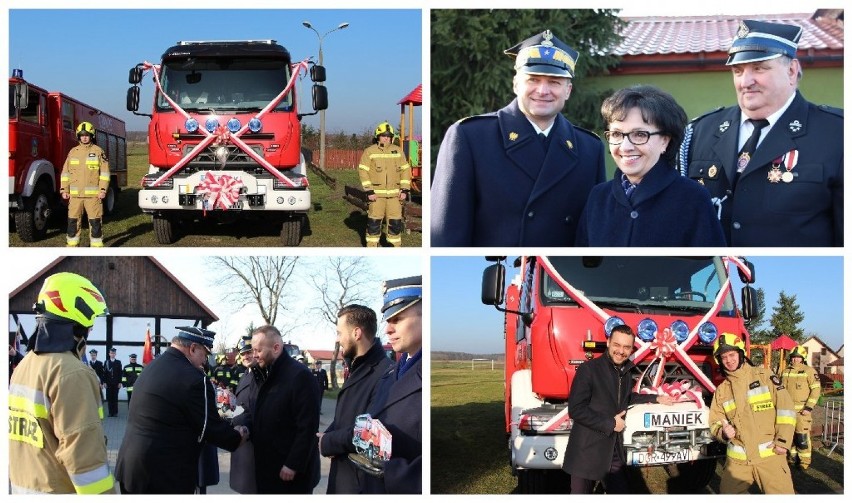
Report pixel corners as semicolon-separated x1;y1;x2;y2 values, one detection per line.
358;122;411;248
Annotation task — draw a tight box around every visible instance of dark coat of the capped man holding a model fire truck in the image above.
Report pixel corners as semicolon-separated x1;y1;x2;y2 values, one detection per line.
364;358;423;494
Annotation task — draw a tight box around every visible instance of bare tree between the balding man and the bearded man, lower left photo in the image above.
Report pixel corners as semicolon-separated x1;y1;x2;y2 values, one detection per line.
308;256;379;389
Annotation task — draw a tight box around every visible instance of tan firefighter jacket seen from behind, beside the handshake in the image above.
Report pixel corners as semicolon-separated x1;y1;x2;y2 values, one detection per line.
9;351;115;494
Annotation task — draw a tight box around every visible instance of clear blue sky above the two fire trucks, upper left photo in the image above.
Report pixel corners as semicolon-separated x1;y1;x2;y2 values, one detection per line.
9;10;423;133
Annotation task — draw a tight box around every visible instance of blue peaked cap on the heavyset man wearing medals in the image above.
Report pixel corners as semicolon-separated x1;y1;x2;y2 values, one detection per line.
725;19;802;65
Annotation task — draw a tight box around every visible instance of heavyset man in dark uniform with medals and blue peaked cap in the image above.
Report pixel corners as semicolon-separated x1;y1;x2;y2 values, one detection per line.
680;21;843;246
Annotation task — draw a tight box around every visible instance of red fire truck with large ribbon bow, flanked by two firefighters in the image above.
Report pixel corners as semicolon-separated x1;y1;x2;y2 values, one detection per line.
127;40;328;246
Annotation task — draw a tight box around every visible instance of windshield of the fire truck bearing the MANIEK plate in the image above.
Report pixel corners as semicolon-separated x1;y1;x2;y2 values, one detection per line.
540;257;735;316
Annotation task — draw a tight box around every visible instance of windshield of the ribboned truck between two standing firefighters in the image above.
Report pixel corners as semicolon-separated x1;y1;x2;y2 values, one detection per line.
157;58;293;112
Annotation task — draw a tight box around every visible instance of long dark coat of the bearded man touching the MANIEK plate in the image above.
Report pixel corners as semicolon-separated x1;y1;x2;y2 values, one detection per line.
562;353;657;480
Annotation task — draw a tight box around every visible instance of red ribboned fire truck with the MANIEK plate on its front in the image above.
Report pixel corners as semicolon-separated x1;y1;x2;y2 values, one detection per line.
482;256;757;493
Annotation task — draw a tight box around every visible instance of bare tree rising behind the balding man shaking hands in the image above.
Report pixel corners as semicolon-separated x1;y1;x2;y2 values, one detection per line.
210;256;304;337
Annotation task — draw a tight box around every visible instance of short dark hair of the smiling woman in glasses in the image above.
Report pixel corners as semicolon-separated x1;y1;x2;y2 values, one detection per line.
601;85;687;166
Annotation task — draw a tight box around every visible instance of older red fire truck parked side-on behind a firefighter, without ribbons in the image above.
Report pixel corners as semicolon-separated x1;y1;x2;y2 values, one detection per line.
9;69;127;242
